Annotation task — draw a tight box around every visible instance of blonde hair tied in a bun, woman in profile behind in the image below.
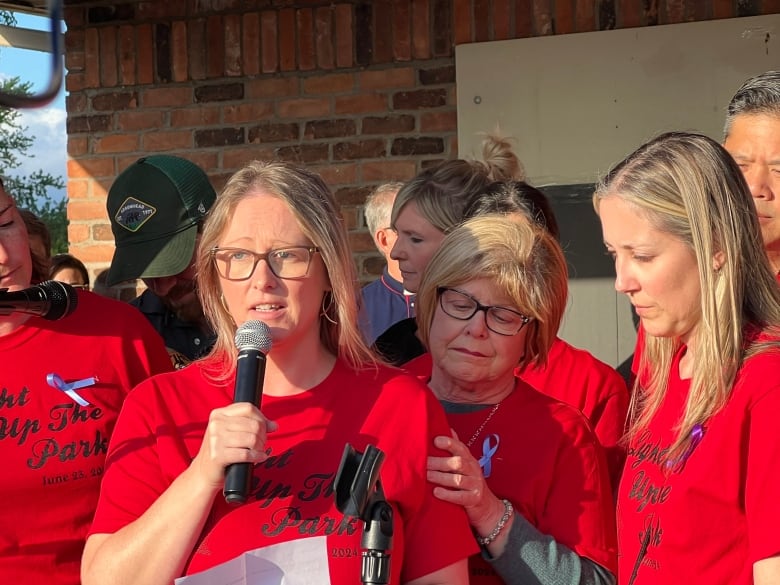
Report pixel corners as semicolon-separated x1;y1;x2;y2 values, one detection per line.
390;135;523;234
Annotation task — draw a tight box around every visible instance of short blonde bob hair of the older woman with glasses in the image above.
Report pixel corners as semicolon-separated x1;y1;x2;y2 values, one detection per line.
417;215;568;368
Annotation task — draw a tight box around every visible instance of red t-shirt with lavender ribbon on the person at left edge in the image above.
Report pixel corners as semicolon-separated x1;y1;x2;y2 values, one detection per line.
0;292;172;585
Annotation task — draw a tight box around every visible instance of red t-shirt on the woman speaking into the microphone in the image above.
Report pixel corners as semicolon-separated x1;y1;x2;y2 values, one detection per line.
91;361;477;584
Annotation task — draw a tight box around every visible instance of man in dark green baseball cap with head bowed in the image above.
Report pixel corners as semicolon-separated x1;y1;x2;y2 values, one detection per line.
106;155;216;367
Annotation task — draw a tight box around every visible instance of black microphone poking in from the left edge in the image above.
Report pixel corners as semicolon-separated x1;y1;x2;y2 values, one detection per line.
0;280;78;321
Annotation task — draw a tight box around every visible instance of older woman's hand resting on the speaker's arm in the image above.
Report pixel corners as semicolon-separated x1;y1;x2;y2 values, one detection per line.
428;431;504;532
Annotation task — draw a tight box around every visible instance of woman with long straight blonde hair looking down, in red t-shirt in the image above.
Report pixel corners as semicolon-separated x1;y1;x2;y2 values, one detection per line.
594;133;780;585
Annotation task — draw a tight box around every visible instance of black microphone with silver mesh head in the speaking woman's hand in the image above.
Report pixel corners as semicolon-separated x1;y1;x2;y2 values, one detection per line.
222;321;272;504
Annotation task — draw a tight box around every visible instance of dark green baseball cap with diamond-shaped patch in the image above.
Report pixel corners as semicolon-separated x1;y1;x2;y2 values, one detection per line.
106;154;217;286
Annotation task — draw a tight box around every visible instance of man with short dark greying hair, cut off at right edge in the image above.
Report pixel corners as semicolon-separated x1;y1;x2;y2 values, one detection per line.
723;71;780;280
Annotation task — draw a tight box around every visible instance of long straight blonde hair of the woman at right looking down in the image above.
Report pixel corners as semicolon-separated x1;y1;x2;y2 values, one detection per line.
593;132;780;457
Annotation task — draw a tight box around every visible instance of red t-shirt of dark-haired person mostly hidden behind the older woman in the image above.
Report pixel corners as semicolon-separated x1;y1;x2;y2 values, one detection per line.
518;338;629;490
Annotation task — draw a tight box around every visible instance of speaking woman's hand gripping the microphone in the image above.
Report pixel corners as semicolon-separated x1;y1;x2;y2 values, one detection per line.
191;402;277;490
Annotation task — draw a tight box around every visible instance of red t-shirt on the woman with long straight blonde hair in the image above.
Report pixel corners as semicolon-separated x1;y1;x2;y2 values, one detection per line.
618;336;780;585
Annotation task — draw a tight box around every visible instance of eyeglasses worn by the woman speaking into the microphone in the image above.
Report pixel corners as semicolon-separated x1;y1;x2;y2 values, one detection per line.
210;246;320;280
